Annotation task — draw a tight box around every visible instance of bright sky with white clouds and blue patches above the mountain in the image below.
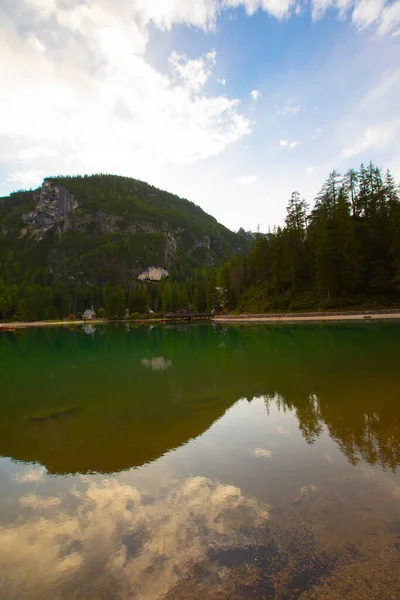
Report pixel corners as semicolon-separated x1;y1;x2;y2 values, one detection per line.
0;0;400;231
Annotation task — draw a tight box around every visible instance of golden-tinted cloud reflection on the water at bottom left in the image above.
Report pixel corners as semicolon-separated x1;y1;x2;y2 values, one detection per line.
0;477;268;600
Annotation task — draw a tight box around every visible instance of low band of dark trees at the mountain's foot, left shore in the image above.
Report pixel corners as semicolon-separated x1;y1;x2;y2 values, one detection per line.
0;264;219;321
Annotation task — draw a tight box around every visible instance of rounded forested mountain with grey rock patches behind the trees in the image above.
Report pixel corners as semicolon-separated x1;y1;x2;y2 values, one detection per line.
0;175;249;289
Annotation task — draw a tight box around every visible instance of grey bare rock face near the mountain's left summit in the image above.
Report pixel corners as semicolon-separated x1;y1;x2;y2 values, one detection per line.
21;181;79;238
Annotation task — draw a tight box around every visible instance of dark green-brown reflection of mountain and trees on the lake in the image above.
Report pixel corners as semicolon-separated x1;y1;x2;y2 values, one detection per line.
0;324;400;473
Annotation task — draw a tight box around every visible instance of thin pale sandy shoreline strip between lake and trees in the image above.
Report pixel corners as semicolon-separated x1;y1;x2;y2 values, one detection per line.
0;309;400;331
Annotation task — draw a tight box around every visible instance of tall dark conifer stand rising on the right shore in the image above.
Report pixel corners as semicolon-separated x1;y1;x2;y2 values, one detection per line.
220;162;400;312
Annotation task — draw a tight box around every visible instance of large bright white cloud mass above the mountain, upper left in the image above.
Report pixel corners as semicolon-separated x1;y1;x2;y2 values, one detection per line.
0;0;252;187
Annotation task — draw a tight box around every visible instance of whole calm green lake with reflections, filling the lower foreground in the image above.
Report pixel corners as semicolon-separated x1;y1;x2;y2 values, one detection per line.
0;323;400;600
